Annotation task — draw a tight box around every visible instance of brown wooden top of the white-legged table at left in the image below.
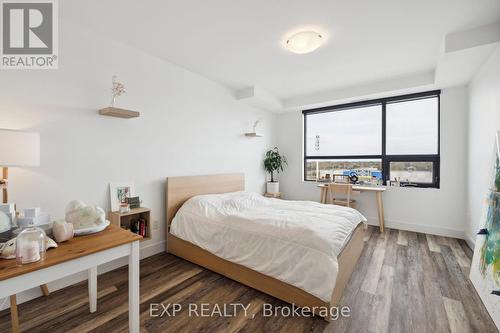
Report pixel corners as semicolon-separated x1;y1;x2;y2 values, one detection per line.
0;225;142;281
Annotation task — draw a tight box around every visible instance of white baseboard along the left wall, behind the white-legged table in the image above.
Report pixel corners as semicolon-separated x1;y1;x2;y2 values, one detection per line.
0;241;165;310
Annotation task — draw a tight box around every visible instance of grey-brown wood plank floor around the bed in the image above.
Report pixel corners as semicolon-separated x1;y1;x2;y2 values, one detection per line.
0;227;497;333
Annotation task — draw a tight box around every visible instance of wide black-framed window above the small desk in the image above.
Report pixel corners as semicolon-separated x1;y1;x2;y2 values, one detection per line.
303;91;440;188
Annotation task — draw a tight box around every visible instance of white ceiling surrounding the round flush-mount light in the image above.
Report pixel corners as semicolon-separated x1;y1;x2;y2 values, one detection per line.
64;0;500;111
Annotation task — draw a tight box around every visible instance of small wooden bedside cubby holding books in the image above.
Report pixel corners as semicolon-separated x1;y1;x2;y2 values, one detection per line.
109;207;151;240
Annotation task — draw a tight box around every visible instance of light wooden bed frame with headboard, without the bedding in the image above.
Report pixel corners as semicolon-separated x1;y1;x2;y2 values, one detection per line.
166;173;364;320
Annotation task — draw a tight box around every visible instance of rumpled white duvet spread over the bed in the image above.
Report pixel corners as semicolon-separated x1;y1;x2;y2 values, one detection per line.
170;192;366;302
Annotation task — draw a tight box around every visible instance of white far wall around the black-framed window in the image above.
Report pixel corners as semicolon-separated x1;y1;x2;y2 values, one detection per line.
277;87;468;238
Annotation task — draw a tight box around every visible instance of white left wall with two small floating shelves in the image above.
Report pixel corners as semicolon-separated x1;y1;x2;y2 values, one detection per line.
0;17;275;300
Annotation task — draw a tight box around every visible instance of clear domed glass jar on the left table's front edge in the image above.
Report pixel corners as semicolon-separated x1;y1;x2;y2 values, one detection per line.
16;226;47;265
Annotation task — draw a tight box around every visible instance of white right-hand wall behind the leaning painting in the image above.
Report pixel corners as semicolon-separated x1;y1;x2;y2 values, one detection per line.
466;47;500;244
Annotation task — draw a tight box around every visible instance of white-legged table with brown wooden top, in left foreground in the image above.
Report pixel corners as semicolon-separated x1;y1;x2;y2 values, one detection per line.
0;225;142;333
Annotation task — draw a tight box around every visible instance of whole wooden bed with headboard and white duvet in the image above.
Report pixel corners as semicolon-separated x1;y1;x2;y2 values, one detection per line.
166;174;366;320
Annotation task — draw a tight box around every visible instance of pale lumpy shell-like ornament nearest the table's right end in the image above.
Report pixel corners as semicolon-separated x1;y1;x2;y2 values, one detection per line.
66;200;109;235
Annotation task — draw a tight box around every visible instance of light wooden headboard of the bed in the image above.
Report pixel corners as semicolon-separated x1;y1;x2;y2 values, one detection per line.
165;173;245;228
